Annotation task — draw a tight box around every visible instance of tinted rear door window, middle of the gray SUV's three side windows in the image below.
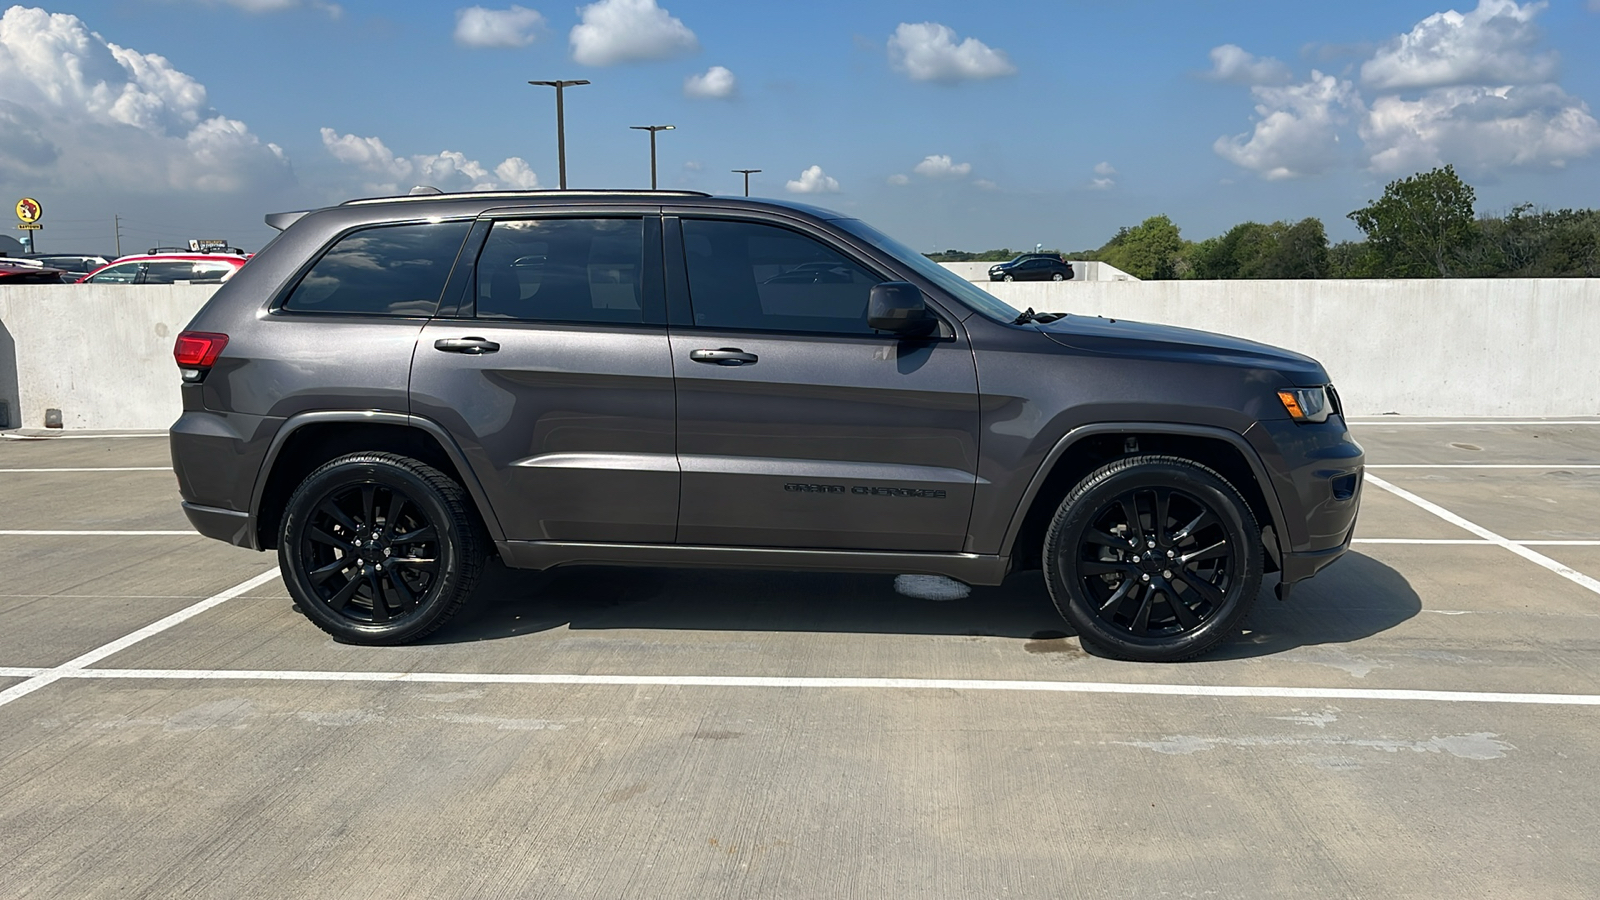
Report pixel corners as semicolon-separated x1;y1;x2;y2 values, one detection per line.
475;218;646;323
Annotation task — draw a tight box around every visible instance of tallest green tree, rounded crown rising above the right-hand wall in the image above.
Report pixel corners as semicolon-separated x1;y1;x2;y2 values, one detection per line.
1349;165;1477;279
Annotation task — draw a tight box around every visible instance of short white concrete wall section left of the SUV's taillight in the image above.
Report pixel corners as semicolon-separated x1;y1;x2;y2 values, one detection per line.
0;285;216;429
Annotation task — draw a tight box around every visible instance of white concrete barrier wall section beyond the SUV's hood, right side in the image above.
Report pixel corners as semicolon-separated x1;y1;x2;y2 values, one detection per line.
984;279;1600;416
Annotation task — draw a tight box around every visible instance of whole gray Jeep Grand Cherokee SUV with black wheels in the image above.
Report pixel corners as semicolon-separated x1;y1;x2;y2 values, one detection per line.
171;191;1363;660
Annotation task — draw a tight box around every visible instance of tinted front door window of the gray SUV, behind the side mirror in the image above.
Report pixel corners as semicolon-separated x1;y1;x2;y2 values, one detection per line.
683;219;885;335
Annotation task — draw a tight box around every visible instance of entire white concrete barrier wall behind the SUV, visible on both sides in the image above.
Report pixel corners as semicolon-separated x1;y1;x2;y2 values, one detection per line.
0;279;1600;429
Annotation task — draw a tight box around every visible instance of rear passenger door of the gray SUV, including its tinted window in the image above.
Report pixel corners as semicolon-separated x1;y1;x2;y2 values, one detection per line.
411;208;678;543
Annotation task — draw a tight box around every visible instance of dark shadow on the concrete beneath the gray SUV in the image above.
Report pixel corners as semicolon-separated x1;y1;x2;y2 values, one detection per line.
422;552;1422;660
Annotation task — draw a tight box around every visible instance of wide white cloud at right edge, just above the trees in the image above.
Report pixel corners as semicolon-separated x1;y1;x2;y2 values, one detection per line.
1362;85;1600;175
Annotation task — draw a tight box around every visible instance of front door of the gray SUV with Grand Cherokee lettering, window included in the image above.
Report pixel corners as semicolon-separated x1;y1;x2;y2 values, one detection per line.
666;218;979;552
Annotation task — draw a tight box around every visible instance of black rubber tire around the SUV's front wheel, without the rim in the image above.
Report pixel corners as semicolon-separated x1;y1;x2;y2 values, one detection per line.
1043;461;1262;661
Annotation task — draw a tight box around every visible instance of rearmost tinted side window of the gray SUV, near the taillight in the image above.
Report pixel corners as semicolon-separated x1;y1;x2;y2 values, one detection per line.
283;223;472;315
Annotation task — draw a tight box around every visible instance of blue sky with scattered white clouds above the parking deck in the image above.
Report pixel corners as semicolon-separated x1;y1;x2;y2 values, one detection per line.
0;0;1600;253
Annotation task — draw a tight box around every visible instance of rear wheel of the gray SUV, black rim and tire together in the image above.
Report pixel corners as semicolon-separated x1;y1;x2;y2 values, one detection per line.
278;453;488;645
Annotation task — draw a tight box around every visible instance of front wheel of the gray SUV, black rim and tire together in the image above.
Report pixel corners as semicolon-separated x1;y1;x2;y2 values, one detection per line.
1043;455;1262;663
